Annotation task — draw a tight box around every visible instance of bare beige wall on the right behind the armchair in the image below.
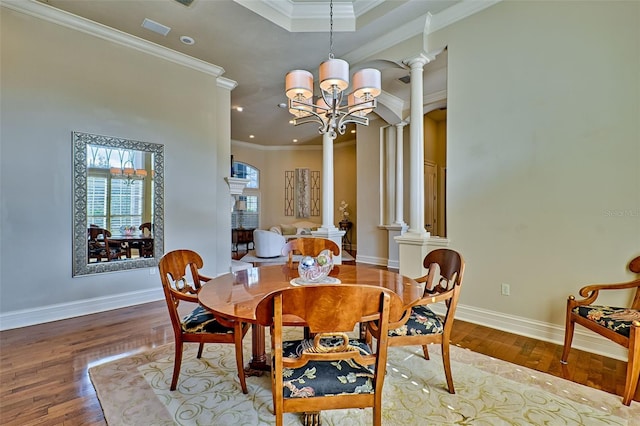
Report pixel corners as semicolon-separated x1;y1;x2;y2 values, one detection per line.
424;1;640;328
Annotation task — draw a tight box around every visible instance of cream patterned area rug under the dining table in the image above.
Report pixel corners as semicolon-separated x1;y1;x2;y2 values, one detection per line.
89;330;640;426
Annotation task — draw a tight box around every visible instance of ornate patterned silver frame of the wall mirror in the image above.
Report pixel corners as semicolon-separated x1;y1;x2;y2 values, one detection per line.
72;132;164;277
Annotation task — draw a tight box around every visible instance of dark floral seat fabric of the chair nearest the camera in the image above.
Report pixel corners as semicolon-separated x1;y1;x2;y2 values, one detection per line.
282;339;373;398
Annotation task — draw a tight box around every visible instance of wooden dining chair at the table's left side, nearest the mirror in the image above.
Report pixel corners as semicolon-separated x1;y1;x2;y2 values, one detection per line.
158;250;250;393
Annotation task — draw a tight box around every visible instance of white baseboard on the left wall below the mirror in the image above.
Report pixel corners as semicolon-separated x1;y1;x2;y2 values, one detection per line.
0;287;164;331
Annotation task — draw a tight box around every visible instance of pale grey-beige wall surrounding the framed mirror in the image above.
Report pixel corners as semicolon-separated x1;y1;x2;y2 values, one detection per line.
0;7;231;328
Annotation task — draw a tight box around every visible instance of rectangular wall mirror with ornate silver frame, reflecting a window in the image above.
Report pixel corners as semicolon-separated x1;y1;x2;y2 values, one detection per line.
72;132;164;276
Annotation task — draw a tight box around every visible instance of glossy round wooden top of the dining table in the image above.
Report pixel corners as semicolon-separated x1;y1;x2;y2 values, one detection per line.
198;265;424;323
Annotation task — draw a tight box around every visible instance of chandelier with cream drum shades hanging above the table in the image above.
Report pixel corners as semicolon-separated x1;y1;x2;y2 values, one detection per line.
285;0;381;139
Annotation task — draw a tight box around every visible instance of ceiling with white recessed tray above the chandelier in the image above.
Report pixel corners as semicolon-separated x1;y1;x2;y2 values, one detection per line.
39;0;461;146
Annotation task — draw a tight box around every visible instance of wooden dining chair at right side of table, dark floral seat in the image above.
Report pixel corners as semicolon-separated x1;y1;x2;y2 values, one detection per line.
367;249;465;394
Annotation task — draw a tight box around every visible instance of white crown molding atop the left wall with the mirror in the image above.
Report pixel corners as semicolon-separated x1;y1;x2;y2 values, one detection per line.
0;0;226;77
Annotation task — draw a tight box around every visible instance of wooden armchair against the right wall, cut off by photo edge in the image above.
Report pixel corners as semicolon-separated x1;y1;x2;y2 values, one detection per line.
560;256;640;405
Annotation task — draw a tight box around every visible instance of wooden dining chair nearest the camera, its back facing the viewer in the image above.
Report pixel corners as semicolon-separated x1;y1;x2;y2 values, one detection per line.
256;284;403;426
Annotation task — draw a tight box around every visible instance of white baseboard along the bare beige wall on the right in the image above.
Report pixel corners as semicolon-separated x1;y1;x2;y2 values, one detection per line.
433;304;628;362
